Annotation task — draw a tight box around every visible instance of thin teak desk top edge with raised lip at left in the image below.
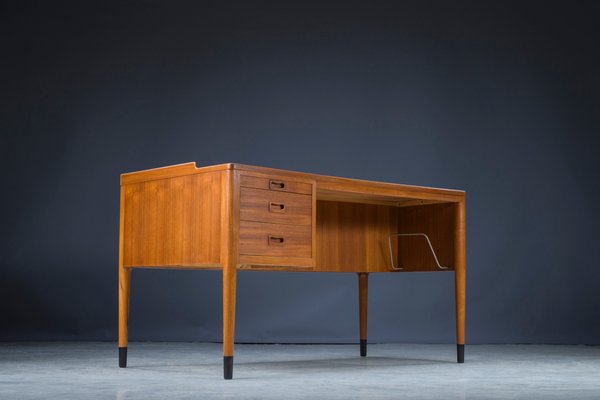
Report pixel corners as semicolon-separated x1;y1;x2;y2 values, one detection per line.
121;162;465;197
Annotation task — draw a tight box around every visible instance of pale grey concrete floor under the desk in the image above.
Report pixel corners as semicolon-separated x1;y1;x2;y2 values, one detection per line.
0;343;600;400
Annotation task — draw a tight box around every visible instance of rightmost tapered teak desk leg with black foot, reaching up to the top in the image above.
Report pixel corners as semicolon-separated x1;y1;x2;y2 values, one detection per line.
454;202;466;363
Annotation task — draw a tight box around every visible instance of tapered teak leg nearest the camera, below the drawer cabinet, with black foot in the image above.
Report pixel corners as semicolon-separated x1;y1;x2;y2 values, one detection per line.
223;265;236;379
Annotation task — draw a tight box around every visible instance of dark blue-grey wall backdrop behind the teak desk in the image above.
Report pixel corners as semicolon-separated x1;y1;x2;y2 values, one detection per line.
0;1;600;344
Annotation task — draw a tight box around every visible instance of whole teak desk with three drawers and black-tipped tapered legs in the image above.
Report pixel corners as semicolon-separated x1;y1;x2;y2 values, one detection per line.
119;163;465;379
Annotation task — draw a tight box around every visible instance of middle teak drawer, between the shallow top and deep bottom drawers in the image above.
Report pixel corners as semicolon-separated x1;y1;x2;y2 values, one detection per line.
240;187;312;225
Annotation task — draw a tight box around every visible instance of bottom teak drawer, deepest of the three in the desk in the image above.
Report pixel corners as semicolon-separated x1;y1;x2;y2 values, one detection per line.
239;221;312;258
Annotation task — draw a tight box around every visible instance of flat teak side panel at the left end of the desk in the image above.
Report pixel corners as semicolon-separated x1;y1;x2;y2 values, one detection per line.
121;171;223;268
